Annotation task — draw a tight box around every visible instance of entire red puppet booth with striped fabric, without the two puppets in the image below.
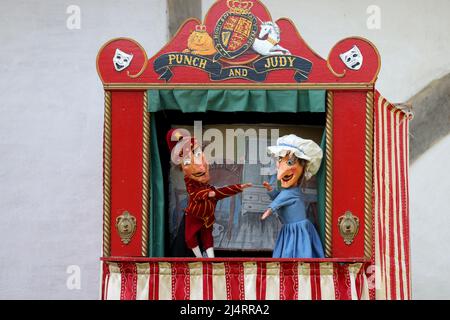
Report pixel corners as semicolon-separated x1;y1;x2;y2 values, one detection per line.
97;0;411;300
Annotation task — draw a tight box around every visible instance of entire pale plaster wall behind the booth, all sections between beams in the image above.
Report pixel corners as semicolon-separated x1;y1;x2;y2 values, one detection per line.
0;0;450;299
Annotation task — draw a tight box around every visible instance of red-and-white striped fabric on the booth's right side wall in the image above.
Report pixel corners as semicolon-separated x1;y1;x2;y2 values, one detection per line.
373;92;411;299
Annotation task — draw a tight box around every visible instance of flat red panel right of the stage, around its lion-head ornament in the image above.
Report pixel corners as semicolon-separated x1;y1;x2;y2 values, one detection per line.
332;91;367;258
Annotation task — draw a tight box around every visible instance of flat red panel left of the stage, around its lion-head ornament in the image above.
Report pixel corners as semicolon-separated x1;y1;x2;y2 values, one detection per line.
111;91;144;256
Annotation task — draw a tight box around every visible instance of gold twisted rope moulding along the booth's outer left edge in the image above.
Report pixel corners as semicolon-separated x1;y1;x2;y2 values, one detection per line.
103;91;111;257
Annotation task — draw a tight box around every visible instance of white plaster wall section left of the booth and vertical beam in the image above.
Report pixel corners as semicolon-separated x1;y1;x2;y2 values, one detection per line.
0;0;167;299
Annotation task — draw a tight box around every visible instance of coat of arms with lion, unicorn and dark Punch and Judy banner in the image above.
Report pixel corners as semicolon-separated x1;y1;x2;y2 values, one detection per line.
153;0;312;82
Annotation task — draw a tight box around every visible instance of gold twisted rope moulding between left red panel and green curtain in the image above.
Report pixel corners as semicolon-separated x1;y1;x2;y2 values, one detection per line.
141;91;150;257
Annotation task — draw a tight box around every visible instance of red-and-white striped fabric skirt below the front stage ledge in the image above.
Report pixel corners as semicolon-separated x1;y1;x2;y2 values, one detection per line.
102;261;370;300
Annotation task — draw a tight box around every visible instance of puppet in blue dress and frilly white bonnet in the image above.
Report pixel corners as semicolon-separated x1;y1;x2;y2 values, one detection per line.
261;134;324;258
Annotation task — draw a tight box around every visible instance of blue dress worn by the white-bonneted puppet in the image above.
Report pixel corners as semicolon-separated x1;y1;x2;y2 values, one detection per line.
269;186;324;258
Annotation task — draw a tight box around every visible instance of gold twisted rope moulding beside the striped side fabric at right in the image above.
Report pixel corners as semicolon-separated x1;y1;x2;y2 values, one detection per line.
364;91;374;259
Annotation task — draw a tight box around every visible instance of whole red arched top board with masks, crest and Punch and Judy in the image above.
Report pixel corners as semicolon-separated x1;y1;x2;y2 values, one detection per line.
97;0;380;87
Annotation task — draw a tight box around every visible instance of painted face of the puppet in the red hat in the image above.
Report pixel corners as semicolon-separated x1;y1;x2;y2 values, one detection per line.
181;145;209;183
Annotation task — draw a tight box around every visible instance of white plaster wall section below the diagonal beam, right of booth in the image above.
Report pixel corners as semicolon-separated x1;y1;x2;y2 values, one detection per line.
410;135;450;300
